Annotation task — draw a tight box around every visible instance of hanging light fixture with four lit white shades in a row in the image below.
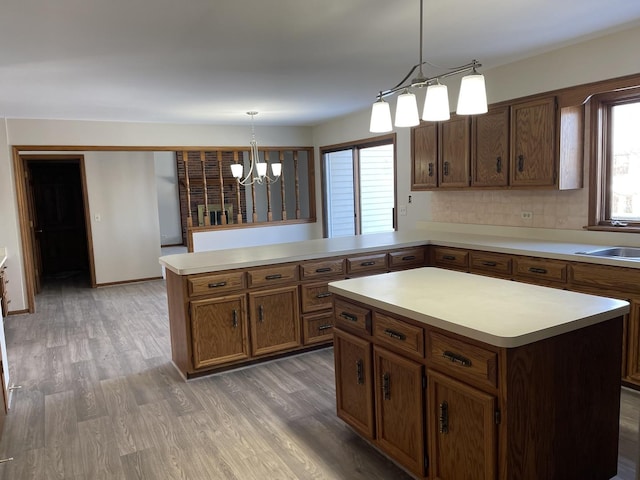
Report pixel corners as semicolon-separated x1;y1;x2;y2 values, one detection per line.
369;0;487;133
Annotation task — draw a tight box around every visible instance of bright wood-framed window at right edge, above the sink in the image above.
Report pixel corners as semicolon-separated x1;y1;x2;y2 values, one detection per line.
589;88;640;230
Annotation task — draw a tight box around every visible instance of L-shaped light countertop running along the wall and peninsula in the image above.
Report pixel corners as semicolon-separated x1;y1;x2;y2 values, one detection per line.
159;230;640;275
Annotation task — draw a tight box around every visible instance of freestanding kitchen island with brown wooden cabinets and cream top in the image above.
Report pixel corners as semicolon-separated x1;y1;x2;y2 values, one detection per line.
329;268;629;480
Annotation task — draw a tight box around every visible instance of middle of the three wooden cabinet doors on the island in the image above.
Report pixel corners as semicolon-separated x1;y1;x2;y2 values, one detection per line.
373;346;425;477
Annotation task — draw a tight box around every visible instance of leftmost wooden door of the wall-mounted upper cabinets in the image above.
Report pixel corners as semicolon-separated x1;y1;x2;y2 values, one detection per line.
411;123;438;190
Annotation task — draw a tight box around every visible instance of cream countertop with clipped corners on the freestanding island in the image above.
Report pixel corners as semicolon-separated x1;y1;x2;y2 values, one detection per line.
329;267;629;348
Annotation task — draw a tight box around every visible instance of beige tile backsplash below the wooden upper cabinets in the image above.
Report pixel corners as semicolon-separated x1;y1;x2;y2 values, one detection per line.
431;188;589;230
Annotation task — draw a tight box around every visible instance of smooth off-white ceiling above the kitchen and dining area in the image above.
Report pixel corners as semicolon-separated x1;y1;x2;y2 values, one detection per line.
0;0;640;126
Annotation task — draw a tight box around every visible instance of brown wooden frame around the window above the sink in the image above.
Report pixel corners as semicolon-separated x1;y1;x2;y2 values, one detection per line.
586;85;640;233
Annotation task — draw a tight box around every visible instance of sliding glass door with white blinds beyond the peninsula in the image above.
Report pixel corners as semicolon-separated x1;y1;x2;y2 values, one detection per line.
321;135;396;238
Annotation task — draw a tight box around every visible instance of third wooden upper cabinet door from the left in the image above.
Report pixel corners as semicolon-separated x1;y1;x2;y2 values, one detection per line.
471;107;509;187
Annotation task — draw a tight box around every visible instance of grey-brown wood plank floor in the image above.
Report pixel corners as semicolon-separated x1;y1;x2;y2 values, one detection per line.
0;274;640;480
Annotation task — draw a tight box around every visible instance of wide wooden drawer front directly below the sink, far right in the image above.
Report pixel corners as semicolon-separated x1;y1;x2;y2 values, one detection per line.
569;263;640;296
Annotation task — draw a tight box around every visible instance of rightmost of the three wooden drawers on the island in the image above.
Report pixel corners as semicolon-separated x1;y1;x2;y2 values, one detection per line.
427;331;498;387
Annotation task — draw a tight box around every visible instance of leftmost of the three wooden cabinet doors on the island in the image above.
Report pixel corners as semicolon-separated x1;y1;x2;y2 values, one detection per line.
333;330;375;440
